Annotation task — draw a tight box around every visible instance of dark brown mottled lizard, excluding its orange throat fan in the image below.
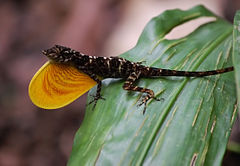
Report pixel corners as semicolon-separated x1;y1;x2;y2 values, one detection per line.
43;45;234;113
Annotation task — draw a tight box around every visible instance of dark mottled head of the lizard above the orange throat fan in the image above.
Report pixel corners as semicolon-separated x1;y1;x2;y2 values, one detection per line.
42;45;74;63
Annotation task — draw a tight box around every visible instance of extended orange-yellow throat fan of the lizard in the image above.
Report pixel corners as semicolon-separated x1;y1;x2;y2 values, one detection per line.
29;62;97;109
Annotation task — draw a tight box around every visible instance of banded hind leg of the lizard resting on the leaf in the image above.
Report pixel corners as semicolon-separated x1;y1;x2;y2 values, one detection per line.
123;72;160;114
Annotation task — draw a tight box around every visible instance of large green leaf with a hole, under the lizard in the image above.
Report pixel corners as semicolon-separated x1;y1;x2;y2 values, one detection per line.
68;6;239;166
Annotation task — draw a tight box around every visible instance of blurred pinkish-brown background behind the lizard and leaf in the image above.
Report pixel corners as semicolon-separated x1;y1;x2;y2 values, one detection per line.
0;0;240;166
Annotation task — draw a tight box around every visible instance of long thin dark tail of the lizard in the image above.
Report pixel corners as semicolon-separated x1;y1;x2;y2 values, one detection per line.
149;67;234;77
